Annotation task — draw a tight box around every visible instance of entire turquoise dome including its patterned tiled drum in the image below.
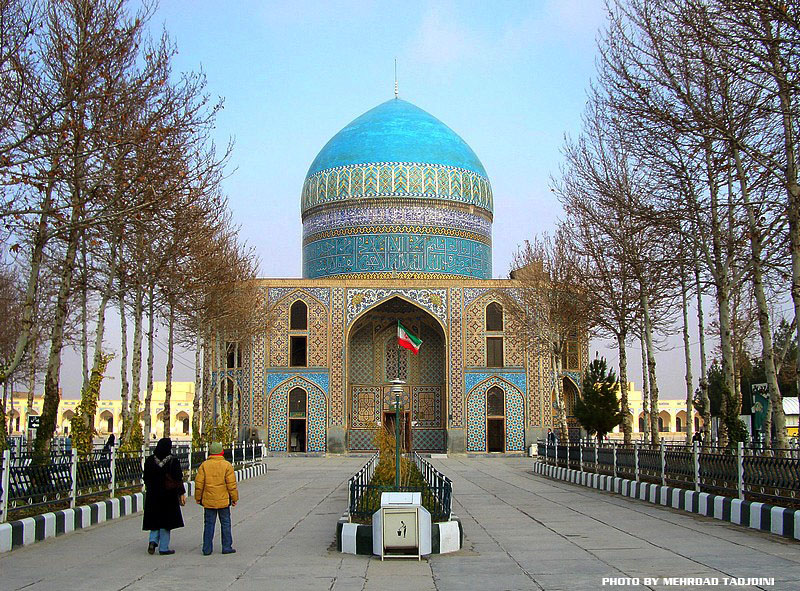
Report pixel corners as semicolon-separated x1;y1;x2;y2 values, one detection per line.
302;99;492;279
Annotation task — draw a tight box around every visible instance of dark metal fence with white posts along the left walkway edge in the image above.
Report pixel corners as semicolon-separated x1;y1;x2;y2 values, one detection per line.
0;442;266;523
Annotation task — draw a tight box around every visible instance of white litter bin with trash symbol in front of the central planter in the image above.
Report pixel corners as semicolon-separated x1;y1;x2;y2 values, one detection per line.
372;492;431;560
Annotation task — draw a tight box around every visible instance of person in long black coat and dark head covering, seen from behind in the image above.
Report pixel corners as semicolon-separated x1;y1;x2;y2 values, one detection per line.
142;437;186;554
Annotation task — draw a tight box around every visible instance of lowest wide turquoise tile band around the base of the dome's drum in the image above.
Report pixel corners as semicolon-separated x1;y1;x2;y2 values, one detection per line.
303;233;492;279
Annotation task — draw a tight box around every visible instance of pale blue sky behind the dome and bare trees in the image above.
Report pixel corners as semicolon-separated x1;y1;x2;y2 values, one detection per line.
53;0;708;398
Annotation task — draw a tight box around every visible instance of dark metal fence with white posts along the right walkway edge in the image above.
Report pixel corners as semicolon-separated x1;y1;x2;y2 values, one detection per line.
538;439;800;506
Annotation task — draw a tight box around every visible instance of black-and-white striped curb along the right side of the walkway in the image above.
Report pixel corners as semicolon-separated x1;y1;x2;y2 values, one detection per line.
533;461;800;540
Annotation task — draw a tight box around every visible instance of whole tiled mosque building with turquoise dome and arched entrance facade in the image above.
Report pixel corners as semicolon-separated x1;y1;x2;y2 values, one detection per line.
222;98;588;453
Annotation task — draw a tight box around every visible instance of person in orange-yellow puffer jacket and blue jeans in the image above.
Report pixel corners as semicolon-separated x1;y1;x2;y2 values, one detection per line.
194;441;239;556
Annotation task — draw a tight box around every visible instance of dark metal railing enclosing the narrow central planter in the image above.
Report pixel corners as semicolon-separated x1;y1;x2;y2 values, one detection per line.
347;452;453;521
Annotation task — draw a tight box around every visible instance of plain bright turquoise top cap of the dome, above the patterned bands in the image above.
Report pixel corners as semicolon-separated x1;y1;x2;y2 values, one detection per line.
306;99;487;178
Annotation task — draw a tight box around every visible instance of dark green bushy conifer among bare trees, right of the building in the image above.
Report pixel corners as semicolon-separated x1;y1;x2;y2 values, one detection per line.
575;357;623;440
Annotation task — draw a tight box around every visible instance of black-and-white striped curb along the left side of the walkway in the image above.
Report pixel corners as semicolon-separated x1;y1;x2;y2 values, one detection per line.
0;463;267;553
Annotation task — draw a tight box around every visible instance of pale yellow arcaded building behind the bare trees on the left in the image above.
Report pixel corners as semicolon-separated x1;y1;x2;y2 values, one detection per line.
6;382;194;439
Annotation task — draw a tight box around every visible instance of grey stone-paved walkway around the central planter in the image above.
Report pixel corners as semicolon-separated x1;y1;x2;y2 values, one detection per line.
0;457;800;591
